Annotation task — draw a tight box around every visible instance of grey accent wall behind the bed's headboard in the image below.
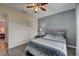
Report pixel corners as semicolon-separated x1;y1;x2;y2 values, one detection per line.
38;9;76;46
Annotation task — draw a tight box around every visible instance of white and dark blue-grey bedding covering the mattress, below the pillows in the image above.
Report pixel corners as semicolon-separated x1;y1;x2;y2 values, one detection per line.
26;38;67;56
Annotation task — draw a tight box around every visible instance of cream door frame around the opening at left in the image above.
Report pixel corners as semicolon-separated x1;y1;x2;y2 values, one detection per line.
0;12;9;55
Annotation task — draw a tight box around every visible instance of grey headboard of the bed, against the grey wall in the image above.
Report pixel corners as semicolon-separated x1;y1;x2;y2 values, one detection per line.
45;29;67;39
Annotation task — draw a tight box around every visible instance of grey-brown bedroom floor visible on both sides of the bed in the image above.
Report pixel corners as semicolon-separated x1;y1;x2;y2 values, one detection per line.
2;44;75;56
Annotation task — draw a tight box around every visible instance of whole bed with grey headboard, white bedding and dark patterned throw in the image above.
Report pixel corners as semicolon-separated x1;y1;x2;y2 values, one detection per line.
26;30;67;56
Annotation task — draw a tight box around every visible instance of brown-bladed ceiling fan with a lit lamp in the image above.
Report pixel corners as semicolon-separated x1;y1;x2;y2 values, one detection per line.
27;3;48;13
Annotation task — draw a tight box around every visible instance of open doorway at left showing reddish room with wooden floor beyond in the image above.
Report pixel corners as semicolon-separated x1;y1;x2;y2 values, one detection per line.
0;13;8;55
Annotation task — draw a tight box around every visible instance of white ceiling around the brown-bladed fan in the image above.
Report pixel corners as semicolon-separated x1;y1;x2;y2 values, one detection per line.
5;3;75;18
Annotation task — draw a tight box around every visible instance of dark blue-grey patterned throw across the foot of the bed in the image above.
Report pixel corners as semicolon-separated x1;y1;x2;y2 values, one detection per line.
27;41;65;56
